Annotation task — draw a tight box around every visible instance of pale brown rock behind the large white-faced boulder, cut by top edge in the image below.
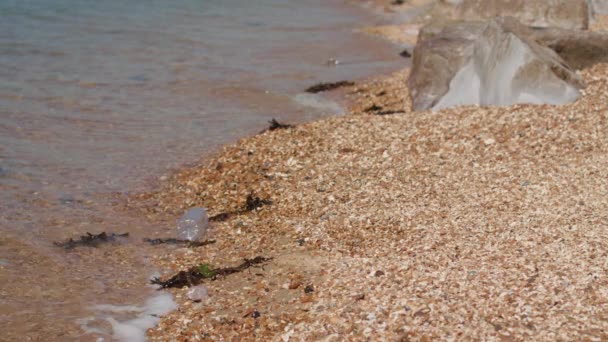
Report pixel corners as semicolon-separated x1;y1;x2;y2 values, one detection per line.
455;0;588;29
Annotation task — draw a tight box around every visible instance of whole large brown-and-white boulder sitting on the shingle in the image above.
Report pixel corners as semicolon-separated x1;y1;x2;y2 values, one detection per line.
408;18;582;110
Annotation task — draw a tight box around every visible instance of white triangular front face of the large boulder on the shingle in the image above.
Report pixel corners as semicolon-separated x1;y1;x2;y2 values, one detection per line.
432;18;581;110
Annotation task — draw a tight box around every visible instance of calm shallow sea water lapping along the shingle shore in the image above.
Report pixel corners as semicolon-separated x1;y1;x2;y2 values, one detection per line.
0;0;403;341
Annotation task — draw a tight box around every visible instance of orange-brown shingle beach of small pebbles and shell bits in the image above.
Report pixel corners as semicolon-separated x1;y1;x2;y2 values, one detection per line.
130;1;608;341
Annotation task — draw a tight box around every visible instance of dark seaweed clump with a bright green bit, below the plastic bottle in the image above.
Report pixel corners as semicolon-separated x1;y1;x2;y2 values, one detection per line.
150;256;272;290
